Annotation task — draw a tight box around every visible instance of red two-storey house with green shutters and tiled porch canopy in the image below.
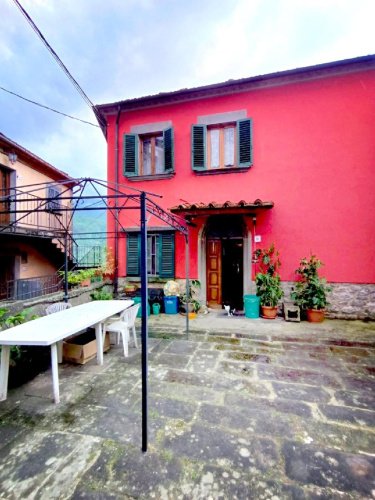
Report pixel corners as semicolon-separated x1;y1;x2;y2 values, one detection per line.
97;56;375;317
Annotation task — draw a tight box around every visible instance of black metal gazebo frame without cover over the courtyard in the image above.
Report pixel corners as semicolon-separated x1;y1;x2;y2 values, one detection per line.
0;177;190;452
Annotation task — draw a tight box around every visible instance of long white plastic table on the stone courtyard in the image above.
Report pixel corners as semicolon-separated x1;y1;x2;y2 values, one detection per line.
0;300;134;404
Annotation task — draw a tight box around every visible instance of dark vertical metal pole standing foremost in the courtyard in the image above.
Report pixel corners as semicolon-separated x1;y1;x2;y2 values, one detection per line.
140;192;148;452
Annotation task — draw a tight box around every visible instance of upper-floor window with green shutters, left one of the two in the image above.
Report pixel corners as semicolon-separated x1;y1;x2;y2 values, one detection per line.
124;128;174;177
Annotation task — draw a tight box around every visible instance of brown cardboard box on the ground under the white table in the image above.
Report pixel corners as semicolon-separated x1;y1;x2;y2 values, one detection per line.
63;330;110;365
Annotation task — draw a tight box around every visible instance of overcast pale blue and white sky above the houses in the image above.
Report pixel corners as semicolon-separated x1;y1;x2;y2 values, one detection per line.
0;0;375;179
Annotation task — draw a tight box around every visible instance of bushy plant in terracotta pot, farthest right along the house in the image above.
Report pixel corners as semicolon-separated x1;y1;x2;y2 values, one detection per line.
291;255;332;323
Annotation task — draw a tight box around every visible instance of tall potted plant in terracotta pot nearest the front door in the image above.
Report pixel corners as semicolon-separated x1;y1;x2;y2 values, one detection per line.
254;243;284;319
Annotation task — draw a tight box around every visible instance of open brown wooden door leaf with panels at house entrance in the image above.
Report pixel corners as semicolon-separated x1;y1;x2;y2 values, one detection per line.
206;239;222;308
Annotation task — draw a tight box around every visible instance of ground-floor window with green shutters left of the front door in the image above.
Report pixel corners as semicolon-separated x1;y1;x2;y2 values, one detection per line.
126;232;175;278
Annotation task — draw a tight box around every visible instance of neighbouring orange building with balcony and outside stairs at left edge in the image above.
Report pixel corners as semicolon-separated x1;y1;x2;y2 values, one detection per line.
0;133;73;299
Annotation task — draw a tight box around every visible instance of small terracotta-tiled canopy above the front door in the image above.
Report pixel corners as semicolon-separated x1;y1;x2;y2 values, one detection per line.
170;199;274;220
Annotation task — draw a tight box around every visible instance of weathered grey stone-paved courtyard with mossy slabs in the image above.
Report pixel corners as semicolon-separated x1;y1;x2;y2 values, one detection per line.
0;313;375;500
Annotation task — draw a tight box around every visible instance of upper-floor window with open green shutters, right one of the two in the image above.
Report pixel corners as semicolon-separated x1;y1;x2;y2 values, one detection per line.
192;119;252;171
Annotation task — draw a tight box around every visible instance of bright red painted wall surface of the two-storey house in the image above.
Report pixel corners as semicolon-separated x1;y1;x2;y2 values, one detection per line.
108;71;375;283
